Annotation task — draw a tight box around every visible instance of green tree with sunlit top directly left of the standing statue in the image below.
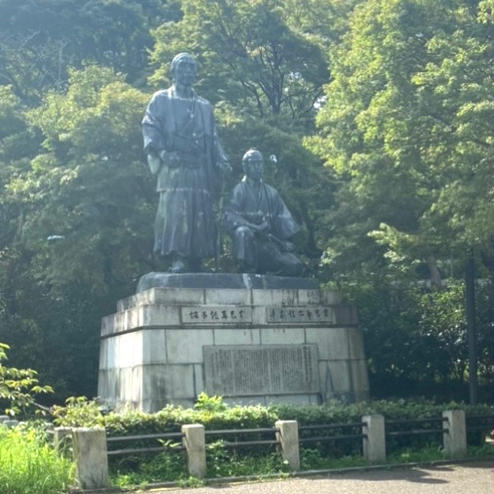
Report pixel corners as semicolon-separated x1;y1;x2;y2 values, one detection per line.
0;66;154;396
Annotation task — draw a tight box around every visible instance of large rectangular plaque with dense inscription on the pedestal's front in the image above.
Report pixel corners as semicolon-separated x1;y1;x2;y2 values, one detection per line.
203;345;319;396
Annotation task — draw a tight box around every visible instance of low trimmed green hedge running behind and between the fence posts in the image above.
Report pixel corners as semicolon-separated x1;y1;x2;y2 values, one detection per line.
51;395;494;487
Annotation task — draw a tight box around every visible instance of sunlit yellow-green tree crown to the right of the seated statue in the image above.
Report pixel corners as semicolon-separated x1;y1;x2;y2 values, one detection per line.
309;0;494;281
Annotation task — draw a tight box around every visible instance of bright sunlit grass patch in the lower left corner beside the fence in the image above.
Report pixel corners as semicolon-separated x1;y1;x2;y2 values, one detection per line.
0;427;74;494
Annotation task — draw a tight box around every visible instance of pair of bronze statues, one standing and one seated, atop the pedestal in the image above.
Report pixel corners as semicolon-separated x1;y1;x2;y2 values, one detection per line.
142;53;304;276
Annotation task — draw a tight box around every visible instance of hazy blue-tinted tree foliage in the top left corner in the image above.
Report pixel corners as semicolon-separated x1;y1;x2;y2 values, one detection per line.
0;0;180;104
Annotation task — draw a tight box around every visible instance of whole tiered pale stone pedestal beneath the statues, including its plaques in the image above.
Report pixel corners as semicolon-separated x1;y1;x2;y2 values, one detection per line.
98;275;369;412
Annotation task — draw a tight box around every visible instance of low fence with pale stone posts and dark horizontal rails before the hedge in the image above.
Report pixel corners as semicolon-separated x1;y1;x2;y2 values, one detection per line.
53;410;484;488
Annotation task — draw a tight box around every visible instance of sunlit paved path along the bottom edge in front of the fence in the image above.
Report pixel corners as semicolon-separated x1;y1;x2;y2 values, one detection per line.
146;462;494;494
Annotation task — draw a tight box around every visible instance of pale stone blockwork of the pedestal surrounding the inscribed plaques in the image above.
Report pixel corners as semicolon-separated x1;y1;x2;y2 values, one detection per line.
98;288;368;411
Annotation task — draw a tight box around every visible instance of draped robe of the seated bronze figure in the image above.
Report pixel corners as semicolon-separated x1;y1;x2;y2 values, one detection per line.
225;177;303;276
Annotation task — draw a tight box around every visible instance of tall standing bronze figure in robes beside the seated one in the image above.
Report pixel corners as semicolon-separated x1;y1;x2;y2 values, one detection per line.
142;53;231;273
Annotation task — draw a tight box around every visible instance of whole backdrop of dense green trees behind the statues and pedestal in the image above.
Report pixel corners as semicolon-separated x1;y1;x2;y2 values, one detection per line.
0;0;494;401
